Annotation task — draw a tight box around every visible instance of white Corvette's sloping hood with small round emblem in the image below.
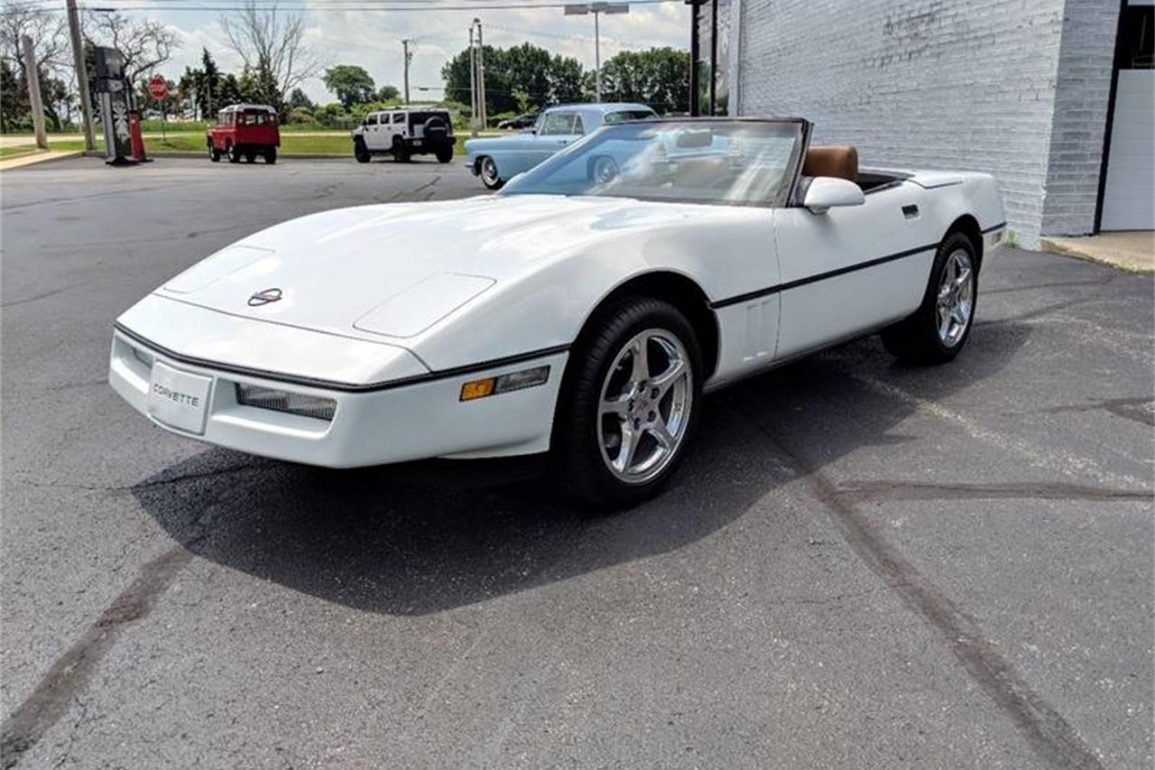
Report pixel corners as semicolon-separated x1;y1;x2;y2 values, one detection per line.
157;195;700;344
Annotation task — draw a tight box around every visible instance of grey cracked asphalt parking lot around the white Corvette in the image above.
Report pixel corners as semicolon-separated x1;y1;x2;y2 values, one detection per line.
0;159;1155;770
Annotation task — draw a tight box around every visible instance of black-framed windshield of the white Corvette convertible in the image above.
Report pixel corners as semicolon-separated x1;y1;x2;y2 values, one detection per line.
502;119;804;205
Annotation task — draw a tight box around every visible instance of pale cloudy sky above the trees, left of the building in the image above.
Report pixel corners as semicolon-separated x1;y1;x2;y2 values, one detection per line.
139;0;690;104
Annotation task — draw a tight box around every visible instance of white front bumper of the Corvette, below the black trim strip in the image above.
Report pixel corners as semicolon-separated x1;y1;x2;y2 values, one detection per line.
109;330;568;468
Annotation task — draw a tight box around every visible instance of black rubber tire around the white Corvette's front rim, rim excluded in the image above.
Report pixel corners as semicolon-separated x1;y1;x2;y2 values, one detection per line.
553;297;703;508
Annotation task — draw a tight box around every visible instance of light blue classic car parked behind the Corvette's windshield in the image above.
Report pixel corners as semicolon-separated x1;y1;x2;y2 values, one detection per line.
465;102;657;189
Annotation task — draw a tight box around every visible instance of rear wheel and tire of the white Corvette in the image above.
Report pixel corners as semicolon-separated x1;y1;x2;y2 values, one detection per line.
882;232;978;364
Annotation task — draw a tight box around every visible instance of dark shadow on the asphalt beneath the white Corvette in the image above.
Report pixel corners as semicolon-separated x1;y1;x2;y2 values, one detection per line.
133;323;1030;615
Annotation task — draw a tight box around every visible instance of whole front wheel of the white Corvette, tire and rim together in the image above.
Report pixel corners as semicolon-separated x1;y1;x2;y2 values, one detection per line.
553;297;703;508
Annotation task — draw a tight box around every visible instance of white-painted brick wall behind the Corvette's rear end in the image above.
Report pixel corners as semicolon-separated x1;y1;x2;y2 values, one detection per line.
737;0;1118;246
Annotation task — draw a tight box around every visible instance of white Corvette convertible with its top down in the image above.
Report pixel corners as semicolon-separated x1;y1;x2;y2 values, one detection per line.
109;119;1005;506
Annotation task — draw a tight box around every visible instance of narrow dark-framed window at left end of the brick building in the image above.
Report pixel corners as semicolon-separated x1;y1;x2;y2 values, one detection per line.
687;0;730;115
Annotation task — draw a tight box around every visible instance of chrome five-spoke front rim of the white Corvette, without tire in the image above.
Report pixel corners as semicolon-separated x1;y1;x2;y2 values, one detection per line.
597;329;694;484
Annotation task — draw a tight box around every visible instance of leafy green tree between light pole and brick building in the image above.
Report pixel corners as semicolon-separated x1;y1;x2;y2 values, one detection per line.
602;47;690;112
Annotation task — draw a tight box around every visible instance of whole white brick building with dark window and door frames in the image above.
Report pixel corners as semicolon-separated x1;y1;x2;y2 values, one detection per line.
687;0;1155;247
